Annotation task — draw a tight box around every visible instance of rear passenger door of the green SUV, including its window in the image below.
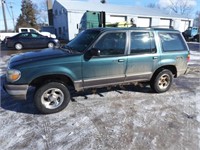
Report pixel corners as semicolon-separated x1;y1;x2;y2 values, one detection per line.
125;31;160;82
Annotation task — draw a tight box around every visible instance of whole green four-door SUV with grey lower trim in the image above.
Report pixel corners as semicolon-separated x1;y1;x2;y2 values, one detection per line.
4;28;189;113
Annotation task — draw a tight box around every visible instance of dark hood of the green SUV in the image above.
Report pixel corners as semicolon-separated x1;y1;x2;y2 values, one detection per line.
10;48;74;68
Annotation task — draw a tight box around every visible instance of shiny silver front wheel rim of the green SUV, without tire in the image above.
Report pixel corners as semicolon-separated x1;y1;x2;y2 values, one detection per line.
41;88;64;109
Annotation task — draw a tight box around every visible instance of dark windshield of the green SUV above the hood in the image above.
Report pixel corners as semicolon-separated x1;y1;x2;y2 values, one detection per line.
64;30;100;52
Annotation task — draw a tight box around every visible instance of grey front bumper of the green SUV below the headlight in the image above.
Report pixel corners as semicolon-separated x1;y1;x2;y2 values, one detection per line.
4;84;29;100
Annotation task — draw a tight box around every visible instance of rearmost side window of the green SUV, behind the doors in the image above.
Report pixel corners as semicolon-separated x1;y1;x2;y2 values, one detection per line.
159;33;187;52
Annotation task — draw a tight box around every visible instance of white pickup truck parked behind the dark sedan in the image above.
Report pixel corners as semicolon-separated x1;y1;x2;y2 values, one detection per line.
0;27;56;41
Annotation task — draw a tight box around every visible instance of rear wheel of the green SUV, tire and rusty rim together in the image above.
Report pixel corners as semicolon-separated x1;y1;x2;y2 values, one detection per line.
150;69;173;93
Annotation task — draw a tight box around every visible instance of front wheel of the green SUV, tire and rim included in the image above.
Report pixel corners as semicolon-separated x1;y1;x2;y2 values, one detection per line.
34;82;70;114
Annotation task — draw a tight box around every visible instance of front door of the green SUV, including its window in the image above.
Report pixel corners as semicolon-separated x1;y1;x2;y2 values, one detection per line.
83;32;127;88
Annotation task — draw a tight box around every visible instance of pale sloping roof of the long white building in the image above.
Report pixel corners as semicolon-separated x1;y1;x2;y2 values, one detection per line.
55;0;188;19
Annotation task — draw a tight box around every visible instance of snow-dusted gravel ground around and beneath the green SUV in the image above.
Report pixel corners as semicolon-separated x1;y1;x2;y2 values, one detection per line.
0;43;200;150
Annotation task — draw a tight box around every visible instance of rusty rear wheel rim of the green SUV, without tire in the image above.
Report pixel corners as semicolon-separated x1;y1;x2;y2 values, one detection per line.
158;74;171;90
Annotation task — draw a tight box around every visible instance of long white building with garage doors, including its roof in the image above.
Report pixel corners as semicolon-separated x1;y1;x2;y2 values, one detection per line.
53;0;193;40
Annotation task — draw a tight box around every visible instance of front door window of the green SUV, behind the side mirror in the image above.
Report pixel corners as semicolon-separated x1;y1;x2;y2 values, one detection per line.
94;32;126;56
